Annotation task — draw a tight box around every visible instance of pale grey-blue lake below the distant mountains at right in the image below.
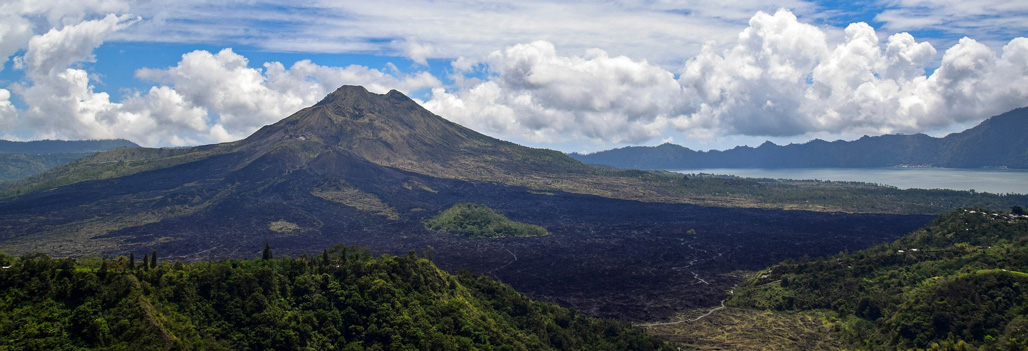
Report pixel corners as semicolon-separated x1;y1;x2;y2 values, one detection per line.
674;168;1028;194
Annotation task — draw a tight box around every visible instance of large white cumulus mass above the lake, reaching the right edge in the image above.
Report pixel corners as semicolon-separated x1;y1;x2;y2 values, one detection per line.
677;10;1028;136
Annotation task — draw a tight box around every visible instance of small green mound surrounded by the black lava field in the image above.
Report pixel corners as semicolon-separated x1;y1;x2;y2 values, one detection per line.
425;203;550;238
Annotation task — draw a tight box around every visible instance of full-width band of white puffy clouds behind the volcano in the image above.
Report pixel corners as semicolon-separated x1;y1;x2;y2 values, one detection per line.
0;0;1028;146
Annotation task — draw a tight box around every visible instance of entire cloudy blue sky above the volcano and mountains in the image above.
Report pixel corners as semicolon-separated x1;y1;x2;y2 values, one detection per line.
0;0;1028;151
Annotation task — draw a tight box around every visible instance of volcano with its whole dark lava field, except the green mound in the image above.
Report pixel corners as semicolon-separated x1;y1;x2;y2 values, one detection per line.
0;86;930;320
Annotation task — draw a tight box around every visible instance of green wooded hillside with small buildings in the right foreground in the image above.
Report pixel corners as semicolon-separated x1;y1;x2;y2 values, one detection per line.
729;210;1028;350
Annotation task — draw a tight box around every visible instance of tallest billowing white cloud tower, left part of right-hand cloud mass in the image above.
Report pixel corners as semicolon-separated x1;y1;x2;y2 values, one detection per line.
678;10;829;136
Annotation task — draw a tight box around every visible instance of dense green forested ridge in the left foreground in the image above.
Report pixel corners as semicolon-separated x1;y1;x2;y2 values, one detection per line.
0;246;665;350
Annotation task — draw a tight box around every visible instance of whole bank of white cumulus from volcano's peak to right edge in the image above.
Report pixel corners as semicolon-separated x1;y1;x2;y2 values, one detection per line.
427;10;1028;143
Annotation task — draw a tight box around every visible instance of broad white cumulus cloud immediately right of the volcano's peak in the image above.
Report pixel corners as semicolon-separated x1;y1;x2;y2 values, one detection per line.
426;41;686;142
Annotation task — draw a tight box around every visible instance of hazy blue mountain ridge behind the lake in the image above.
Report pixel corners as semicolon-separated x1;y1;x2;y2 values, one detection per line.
570;107;1028;170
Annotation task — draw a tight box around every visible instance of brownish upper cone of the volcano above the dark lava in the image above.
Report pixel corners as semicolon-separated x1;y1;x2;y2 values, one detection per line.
240;85;582;180
